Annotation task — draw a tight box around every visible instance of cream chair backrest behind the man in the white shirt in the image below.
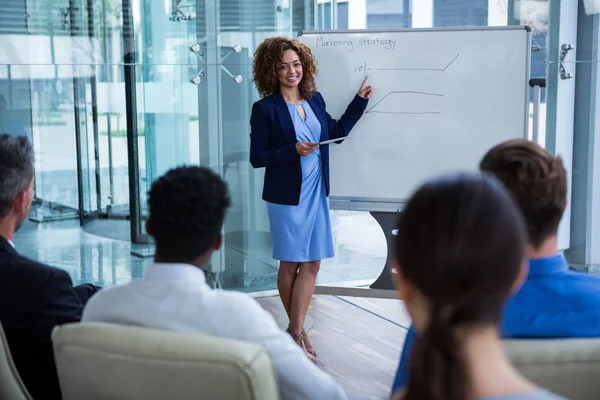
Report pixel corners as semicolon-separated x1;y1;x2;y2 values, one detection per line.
52;323;279;400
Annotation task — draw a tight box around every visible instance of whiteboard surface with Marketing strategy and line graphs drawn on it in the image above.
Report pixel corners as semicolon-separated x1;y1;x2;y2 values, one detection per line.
299;27;531;211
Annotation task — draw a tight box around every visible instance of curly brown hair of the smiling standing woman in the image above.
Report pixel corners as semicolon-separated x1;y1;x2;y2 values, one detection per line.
252;36;317;100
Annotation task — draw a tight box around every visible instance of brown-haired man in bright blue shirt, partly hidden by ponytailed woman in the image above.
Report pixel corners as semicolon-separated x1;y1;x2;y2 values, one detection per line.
392;139;600;391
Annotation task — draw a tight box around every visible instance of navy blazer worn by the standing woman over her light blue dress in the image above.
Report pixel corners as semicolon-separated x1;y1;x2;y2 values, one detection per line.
250;91;369;206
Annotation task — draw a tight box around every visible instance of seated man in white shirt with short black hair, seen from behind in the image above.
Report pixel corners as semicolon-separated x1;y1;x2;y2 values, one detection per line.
82;167;347;399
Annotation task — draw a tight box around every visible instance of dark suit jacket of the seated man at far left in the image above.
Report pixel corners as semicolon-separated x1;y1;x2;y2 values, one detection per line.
0;237;97;400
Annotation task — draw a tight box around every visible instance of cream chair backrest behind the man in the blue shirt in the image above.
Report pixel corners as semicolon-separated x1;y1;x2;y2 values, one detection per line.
503;339;600;400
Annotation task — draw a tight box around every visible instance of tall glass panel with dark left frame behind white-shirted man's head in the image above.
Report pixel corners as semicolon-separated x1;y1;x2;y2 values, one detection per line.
123;0;205;247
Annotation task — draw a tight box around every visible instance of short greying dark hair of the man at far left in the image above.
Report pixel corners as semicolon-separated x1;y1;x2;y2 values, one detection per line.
0;134;34;218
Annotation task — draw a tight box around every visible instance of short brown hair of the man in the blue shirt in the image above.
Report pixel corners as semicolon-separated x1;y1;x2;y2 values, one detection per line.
479;139;567;248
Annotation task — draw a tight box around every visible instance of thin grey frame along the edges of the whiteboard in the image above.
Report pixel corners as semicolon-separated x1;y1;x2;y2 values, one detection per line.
298;25;535;212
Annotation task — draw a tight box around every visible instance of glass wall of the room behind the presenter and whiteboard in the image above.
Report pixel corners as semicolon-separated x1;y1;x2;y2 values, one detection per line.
0;0;597;290
